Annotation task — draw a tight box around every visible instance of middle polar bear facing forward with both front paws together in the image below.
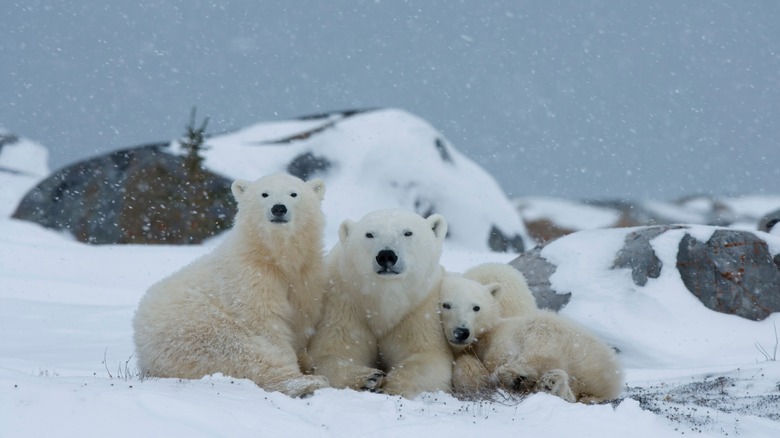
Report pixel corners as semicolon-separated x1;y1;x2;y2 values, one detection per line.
310;209;452;398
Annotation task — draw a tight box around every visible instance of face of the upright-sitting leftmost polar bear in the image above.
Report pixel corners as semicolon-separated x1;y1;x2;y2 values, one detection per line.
231;173;325;228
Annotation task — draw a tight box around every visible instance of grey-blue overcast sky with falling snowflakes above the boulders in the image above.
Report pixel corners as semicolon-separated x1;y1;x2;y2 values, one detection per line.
0;0;780;199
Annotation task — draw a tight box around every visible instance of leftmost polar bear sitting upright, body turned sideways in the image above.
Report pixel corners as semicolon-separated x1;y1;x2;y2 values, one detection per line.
133;173;328;397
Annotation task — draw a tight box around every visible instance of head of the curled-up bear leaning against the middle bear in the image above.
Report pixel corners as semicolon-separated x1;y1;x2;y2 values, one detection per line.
440;275;501;349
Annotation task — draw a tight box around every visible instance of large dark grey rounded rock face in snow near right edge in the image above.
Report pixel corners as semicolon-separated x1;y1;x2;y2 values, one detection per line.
677;230;780;321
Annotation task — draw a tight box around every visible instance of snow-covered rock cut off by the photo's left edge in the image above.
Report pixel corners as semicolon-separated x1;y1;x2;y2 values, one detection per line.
0;128;49;217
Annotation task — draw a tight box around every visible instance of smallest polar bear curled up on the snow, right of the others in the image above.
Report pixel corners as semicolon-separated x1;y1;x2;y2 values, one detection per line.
441;276;623;403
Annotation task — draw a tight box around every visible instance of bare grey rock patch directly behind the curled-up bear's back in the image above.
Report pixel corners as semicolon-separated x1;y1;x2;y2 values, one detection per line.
509;247;571;312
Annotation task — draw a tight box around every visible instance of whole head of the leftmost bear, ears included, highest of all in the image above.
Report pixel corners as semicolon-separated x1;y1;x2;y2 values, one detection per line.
231;173;325;241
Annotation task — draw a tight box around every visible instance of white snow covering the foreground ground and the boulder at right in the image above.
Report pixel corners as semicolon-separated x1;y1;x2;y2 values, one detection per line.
0;210;780;438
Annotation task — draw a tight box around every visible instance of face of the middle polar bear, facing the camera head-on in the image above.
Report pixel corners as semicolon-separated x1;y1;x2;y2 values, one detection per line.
339;209;447;279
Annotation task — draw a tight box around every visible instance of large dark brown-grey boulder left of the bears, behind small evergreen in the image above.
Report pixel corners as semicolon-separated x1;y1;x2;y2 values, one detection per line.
13;144;236;244
